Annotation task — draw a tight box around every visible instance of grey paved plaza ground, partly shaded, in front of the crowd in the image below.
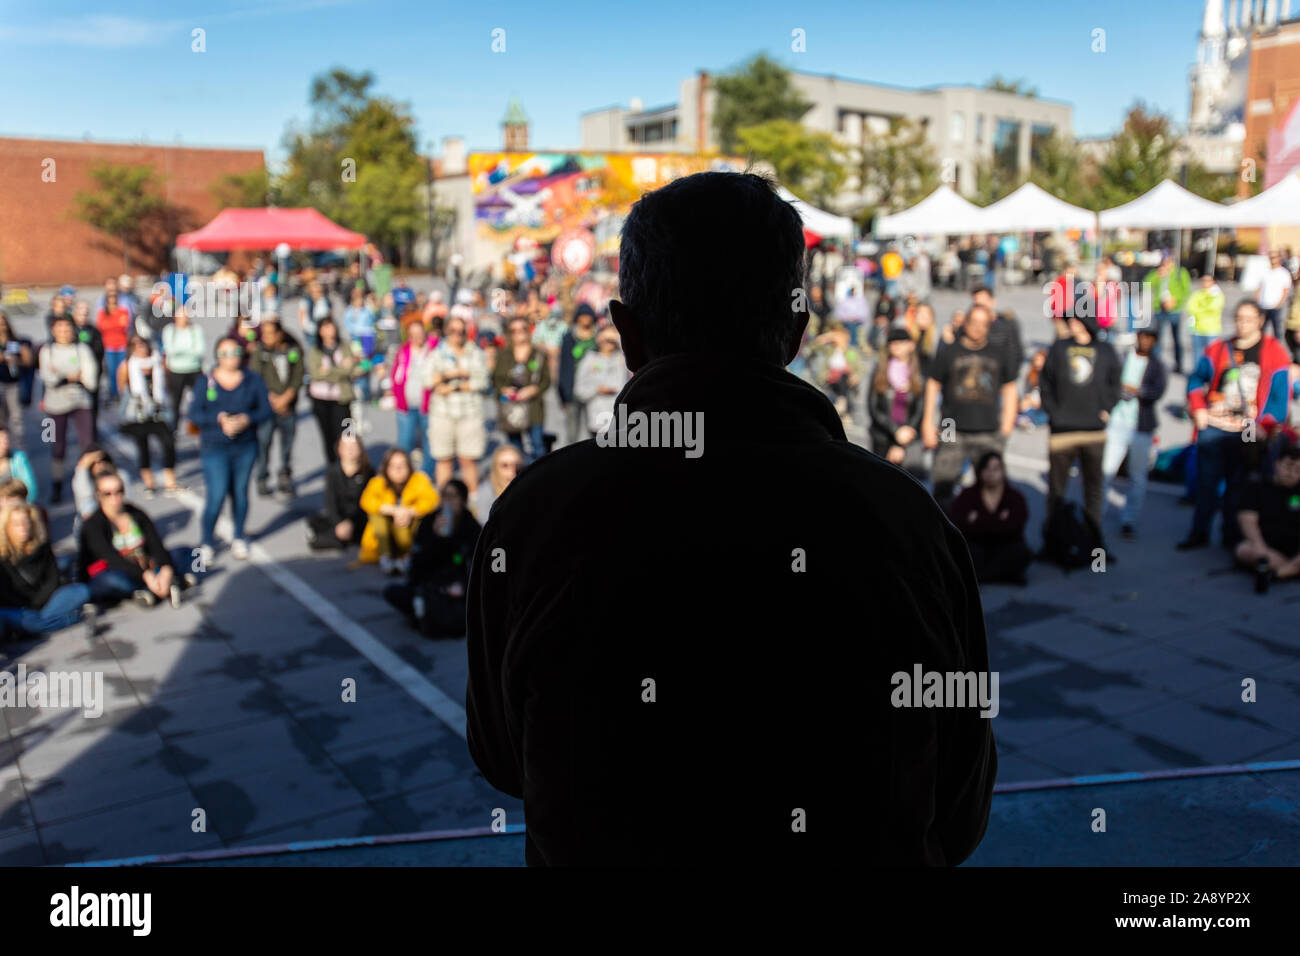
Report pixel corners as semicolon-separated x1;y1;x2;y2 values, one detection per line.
0;278;1300;865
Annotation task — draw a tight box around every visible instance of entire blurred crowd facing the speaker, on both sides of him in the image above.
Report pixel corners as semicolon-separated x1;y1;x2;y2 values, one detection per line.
0;238;1300;642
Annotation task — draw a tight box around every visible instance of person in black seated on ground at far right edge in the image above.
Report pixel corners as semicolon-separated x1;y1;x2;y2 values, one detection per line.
1236;445;1300;594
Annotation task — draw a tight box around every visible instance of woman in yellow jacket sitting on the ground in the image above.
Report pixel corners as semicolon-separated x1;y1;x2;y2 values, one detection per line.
358;446;438;575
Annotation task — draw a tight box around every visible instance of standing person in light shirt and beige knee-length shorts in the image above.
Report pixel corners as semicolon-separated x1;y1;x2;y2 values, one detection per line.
428;310;488;494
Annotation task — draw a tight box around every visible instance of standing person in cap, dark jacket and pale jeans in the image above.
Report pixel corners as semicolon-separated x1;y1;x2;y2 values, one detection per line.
1101;325;1169;540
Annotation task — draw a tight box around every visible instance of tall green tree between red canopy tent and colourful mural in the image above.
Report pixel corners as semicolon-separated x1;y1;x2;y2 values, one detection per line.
273;69;428;260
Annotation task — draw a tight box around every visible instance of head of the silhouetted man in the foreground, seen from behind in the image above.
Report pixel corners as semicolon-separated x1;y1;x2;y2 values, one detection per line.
619;172;806;365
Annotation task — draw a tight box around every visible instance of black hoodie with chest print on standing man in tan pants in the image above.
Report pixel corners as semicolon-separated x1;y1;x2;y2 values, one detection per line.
1039;330;1123;434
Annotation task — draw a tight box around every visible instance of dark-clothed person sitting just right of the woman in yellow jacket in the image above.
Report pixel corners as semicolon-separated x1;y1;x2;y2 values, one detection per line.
384;479;482;637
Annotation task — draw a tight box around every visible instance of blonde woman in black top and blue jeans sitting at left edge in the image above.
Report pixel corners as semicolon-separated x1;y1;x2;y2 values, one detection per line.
0;502;90;633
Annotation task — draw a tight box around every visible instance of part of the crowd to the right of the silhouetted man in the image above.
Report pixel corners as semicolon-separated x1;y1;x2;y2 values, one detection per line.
802;250;1300;589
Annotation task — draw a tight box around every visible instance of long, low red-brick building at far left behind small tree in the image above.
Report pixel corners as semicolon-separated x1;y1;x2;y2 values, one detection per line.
0;138;265;285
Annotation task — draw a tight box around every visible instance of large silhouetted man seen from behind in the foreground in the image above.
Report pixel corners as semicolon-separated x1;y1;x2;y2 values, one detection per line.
465;173;997;865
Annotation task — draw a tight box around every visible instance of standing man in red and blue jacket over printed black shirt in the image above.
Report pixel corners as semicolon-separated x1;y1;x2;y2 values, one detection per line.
1178;299;1291;551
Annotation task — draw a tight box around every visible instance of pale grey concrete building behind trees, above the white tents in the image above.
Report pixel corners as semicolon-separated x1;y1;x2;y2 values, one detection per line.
581;72;1073;211
